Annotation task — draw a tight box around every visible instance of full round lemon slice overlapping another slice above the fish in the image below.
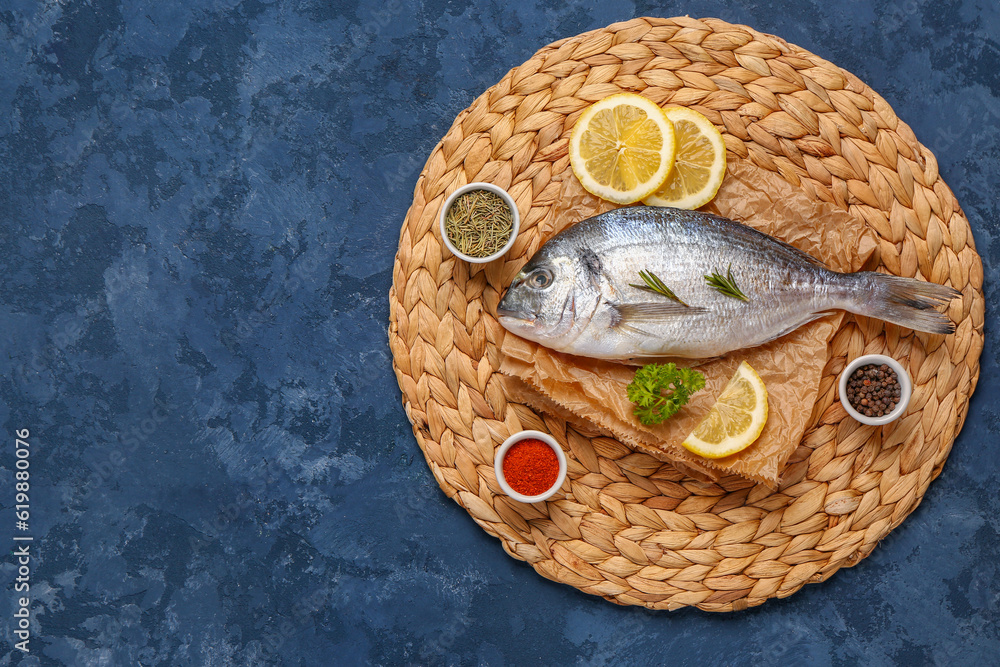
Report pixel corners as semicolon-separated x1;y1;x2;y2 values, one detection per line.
569;93;674;204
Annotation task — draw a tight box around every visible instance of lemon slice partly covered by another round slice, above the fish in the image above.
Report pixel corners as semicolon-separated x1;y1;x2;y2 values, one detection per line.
643;107;726;210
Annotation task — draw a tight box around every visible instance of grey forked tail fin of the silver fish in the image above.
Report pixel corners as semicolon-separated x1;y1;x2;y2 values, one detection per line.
845;271;962;334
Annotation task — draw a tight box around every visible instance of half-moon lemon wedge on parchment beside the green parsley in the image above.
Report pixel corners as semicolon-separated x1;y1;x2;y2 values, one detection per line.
681;361;767;459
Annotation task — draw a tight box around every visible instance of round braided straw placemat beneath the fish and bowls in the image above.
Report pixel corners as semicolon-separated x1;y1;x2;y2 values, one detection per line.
389;18;984;611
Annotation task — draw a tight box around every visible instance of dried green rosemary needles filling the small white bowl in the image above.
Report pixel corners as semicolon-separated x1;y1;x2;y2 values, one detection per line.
444;190;514;257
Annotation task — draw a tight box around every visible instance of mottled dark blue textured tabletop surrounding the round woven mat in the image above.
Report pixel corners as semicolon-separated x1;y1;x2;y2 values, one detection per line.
0;0;1000;666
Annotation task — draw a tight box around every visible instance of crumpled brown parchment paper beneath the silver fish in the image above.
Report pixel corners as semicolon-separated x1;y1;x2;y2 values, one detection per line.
500;159;877;488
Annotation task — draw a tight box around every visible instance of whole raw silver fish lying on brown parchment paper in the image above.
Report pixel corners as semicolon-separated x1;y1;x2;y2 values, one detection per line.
497;207;959;360
